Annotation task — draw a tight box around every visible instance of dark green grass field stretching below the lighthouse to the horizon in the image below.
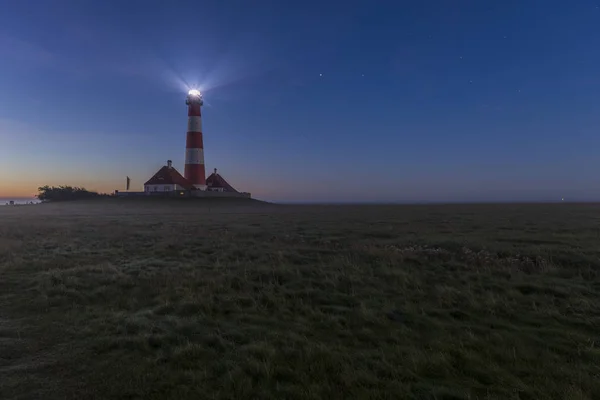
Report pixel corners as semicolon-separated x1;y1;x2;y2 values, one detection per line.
0;200;600;399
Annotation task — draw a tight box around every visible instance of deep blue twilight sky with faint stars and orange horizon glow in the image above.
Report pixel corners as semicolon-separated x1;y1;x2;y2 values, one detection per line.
0;0;600;202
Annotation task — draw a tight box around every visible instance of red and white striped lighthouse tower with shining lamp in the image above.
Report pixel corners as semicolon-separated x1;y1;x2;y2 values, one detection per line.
183;90;206;190
